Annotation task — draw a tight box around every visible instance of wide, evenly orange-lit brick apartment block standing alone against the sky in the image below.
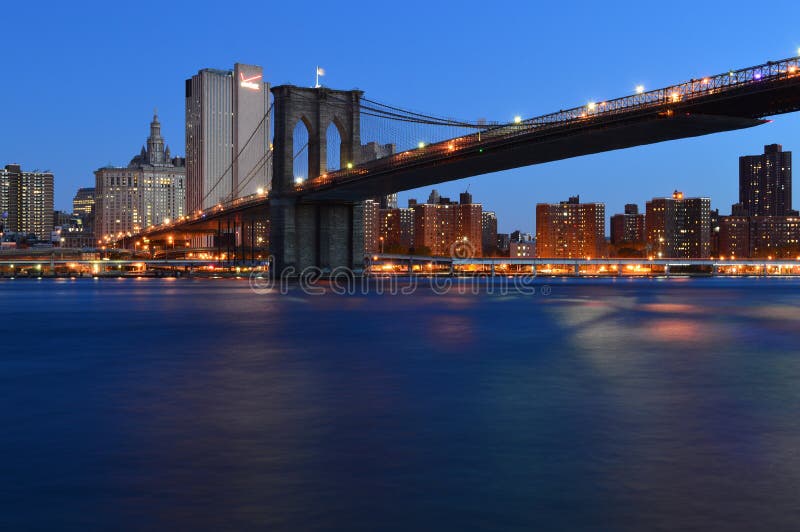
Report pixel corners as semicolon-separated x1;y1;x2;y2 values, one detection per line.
536;196;606;258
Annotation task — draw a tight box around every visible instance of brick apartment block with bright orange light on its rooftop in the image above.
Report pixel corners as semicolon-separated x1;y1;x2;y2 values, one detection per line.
645;190;711;259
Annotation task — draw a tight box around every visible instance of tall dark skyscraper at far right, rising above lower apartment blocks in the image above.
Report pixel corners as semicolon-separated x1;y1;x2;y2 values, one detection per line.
738;144;796;216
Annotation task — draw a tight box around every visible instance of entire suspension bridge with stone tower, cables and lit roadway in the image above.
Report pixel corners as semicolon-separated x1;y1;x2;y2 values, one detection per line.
117;57;800;272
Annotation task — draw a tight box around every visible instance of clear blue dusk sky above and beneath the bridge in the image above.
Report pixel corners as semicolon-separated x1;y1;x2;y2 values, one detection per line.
0;1;800;231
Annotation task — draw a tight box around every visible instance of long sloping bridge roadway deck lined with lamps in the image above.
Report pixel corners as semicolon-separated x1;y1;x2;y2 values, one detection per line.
133;52;800;243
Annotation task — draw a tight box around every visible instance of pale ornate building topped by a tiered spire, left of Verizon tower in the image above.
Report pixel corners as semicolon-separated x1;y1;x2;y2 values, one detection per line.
94;115;186;240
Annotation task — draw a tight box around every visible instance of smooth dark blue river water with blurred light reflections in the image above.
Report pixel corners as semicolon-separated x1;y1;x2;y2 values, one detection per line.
0;279;800;531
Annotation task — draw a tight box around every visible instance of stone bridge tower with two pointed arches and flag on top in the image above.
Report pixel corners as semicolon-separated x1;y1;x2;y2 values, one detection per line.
270;85;364;275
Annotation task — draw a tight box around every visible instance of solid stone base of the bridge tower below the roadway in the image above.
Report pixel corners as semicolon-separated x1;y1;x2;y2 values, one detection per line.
270;198;364;277
